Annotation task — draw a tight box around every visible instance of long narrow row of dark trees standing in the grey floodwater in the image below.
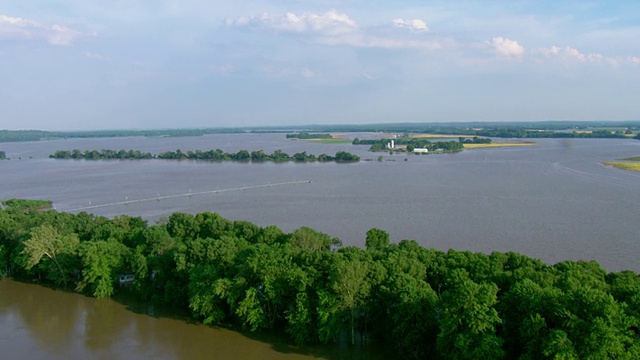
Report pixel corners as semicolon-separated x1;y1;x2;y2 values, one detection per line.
49;149;360;162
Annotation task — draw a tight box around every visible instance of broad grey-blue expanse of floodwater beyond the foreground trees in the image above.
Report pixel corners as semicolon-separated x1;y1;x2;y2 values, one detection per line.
0;134;640;271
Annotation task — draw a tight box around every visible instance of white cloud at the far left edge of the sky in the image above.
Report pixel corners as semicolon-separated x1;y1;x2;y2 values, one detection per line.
0;14;83;45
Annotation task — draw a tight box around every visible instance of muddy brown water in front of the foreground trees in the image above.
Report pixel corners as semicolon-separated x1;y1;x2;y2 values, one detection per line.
0;279;379;360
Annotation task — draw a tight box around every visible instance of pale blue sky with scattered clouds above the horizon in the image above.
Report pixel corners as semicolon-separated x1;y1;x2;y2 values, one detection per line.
0;0;640;130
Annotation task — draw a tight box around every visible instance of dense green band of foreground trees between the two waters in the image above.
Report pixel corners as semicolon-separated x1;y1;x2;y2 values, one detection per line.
0;199;640;359
